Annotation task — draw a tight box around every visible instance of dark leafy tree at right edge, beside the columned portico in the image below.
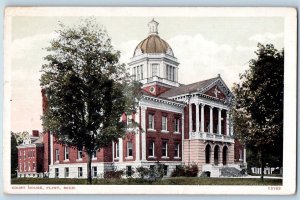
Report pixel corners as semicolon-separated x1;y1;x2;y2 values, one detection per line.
233;44;284;181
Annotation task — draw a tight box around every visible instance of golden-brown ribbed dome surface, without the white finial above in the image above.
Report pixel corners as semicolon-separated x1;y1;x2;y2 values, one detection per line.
134;34;173;56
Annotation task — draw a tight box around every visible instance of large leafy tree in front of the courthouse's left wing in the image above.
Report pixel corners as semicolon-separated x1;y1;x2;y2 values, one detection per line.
40;19;139;183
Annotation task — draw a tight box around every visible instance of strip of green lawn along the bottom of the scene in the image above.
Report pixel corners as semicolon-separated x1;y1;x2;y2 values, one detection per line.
11;177;282;185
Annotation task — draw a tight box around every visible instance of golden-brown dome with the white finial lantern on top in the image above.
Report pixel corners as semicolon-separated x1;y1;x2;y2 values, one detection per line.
133;19;174;56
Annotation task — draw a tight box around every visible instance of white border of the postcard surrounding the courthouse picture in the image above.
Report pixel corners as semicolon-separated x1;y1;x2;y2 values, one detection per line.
3;7;297;195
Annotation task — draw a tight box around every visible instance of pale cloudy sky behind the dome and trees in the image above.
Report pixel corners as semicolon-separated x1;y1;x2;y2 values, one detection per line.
11;16;284;132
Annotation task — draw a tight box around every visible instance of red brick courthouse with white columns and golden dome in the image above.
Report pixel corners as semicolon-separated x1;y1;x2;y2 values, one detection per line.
17;20;243;178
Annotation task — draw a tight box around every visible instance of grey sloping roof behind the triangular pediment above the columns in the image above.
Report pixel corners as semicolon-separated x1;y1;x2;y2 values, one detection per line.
159;77;219;98
